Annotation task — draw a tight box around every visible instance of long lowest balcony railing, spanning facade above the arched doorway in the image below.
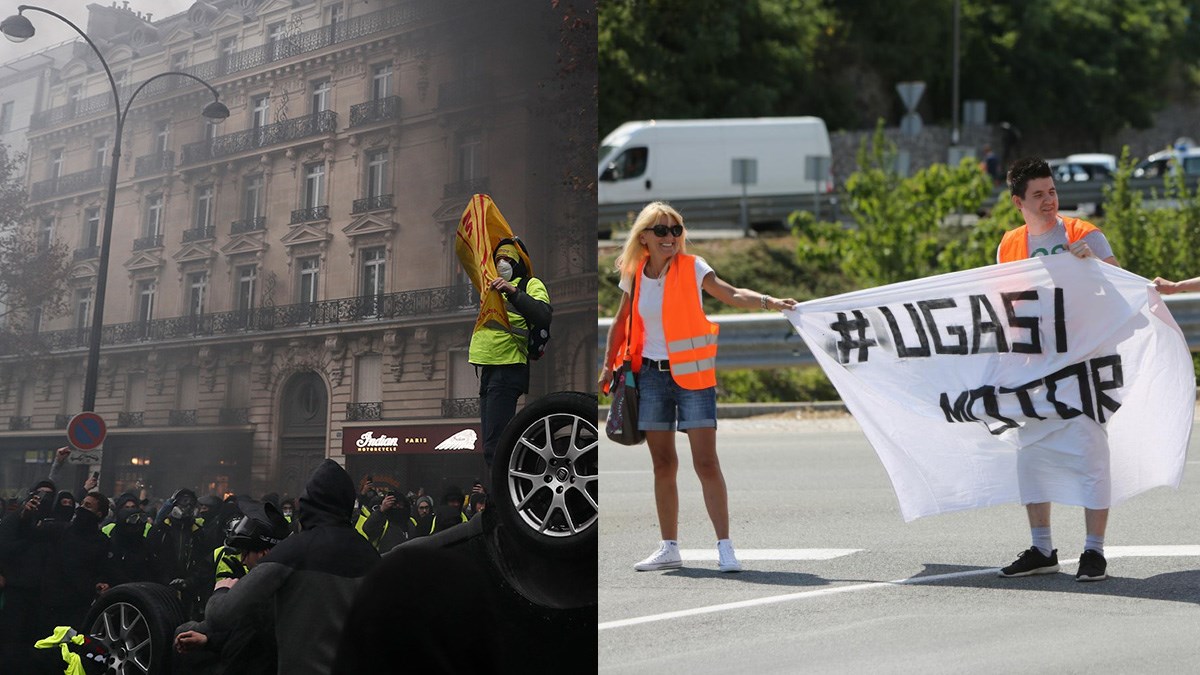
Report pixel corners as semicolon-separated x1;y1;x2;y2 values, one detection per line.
12;285;479;354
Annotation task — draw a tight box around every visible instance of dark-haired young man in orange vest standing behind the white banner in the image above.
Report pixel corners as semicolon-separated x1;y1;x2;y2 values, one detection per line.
996;159;1117;581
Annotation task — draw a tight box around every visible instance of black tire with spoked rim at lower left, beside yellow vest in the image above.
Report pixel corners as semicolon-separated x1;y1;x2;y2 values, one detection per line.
83;583;184;675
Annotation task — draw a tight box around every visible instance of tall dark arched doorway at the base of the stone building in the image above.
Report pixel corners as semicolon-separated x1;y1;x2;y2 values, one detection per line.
277;371;329;497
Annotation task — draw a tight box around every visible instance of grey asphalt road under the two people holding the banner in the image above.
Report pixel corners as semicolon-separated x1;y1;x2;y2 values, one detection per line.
599;418;1200;675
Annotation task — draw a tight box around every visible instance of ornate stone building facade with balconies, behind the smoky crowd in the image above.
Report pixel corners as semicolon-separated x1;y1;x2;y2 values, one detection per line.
0;0;596;497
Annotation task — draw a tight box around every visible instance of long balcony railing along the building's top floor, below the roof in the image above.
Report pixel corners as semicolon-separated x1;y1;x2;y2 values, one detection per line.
29;2;425;131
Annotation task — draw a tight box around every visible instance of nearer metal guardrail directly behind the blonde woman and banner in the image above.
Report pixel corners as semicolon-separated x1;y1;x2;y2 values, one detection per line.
596;293;1200;370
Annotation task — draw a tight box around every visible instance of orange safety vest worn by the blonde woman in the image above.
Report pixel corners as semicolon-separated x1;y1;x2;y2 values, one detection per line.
622;253;721;389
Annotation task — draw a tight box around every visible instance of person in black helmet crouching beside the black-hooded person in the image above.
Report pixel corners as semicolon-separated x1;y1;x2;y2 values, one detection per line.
174;500;292;675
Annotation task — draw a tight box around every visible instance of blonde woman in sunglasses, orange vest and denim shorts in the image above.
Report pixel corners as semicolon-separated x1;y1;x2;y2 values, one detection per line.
600;202;796;572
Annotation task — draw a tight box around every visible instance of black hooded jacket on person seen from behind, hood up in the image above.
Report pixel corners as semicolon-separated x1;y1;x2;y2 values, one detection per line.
204;459;379;675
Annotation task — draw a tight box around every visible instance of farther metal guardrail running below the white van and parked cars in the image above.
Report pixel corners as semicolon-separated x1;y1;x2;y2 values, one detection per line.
598;172;1200;234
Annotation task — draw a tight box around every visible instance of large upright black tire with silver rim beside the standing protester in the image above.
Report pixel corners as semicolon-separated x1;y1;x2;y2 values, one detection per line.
488;392;600;554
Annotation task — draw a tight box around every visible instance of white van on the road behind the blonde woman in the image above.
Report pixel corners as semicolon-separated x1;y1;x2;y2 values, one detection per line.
596;117;832;204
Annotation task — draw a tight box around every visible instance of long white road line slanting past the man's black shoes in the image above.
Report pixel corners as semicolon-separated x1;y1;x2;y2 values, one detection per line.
598;545;1200;631
